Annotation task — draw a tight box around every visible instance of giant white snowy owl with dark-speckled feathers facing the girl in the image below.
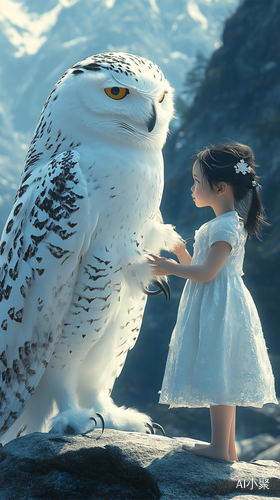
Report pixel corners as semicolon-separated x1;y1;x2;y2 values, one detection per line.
0;52;180;443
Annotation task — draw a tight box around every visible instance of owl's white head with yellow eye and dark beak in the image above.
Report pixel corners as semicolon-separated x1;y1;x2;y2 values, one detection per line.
39;52;174;152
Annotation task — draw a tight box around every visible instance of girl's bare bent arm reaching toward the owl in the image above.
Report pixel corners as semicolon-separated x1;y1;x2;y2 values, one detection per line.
149;241;231;283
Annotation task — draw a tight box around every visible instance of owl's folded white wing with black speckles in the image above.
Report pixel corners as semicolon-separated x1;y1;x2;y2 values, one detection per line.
0;150;98;433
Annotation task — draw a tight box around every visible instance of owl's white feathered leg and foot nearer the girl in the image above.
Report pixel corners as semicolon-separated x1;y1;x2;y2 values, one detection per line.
72;286;163;433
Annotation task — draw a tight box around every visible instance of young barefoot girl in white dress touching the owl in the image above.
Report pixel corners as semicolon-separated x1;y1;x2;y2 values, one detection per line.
150;143;278;461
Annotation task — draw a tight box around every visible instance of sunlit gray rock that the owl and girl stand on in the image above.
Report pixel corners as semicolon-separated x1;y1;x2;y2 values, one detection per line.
0;430;280;500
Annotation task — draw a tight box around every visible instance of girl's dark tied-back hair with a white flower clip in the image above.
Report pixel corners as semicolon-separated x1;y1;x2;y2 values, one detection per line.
192;142;269;237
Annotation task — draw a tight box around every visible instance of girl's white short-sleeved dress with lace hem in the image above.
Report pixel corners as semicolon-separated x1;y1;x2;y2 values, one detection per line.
159;211;278;407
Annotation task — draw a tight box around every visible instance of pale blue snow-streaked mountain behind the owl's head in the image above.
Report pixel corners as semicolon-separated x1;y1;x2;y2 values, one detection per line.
0;0;239;229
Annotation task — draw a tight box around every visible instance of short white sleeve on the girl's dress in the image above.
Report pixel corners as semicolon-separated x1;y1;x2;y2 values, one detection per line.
209;216;239;249
